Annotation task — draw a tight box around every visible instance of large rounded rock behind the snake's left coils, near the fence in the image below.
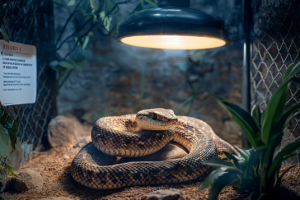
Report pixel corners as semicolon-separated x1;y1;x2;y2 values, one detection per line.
48;115;81;148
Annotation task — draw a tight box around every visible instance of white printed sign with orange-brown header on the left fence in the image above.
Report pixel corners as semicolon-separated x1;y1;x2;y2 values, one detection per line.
0;40;37;106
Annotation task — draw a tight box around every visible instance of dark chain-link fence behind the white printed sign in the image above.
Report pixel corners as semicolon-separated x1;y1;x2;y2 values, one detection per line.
0;0;56;159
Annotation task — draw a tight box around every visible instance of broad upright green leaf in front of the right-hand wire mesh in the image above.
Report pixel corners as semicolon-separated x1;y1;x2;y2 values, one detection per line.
261;81;289;145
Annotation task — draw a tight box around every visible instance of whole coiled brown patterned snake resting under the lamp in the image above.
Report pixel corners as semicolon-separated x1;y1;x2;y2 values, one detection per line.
71;108;237;189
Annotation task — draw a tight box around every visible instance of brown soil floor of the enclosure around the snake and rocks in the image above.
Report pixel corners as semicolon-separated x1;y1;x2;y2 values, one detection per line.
4;146;300;200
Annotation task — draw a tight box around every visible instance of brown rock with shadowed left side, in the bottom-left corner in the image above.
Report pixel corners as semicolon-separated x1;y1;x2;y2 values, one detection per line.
5;168;43;192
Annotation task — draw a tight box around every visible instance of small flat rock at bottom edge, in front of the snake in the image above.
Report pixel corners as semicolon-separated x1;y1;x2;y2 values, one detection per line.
146;189;182;200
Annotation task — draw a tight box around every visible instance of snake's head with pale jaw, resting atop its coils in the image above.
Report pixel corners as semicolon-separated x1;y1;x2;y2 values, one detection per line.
136;108;178;130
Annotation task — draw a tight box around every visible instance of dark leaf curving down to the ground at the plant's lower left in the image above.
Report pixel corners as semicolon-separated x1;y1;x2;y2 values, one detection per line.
209;171;240;200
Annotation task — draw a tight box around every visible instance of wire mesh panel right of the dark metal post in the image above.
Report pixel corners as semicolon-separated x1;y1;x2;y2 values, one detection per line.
251;0;300;165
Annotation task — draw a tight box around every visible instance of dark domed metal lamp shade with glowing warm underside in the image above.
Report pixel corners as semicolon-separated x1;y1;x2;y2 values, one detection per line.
117;6;230;50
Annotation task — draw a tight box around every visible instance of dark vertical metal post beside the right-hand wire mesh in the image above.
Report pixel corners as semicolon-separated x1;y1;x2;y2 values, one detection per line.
242;0;252;147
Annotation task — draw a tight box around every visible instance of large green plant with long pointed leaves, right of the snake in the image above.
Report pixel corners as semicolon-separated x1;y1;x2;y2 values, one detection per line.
200;64;300;199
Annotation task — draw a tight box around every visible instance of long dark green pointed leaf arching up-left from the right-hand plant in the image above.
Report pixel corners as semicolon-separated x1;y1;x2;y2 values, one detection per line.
210;93;259;149
